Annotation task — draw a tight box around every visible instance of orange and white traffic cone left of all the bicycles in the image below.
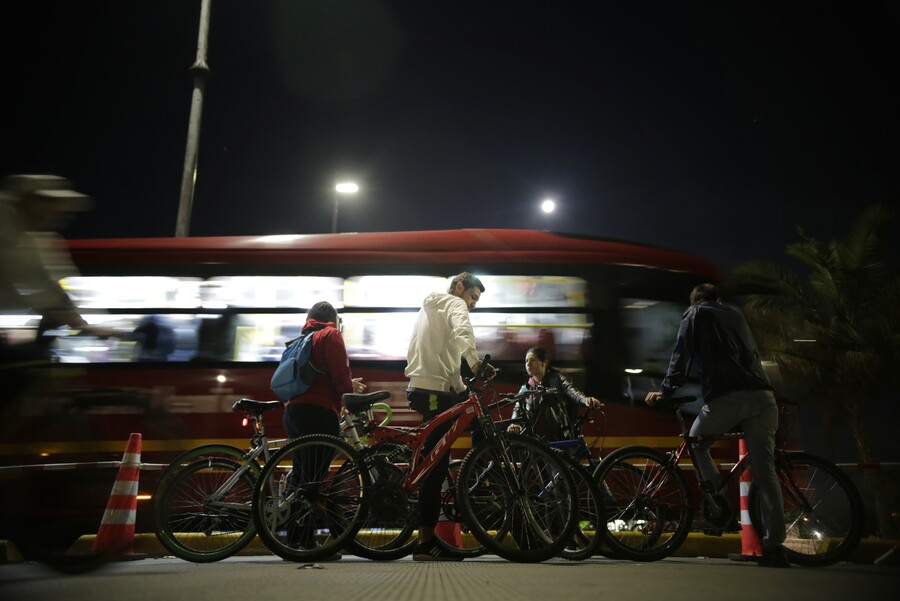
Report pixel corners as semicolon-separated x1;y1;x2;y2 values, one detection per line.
91;434;145;559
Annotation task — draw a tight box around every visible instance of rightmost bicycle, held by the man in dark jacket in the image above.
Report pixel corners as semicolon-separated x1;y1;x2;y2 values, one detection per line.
595;397;863;566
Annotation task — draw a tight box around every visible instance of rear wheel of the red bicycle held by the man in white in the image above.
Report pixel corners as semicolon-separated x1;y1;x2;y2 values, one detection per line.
253;434;369;561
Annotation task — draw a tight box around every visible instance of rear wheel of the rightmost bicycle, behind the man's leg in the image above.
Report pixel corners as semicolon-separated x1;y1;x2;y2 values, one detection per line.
748;452;863;566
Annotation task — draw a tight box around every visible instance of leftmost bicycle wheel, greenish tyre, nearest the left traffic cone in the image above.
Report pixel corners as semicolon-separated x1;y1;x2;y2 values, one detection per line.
153;457;259;563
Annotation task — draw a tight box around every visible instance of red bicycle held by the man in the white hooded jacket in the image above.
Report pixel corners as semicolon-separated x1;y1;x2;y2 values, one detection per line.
253;357;578;562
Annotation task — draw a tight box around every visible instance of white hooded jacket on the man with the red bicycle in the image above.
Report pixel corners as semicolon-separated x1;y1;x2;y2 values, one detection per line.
404;292;479;392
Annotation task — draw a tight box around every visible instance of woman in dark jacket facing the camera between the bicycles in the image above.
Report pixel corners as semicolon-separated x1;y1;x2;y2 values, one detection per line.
509;346;602;441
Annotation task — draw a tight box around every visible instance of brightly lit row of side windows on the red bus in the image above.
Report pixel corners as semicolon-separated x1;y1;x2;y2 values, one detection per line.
40;275;592;363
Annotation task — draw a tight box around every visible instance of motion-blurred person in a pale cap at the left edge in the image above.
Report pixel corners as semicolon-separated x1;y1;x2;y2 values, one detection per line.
0;175;93;363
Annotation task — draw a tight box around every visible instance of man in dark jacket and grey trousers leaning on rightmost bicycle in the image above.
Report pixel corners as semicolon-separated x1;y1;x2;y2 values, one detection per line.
645;284;790;567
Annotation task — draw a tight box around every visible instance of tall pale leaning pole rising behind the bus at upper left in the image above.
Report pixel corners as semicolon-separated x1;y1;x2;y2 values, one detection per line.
175;0;212;237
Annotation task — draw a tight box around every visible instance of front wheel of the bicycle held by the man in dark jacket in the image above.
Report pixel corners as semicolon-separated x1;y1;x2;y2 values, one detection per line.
594;446;693;561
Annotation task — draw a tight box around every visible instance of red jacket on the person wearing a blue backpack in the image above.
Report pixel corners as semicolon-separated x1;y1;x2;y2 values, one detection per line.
288;319;353;416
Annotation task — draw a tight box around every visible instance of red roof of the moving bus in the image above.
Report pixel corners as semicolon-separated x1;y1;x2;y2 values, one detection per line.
69;229;719;280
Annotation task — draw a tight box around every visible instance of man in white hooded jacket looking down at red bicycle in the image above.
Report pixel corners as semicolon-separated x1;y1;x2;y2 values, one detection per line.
404;272;492;561
